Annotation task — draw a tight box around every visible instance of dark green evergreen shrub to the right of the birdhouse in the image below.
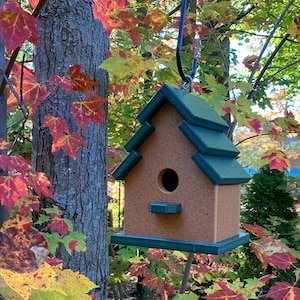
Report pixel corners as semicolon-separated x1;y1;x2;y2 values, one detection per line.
241;165;298;247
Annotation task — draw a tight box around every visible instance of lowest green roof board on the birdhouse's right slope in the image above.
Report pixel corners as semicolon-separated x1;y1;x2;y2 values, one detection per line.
192;152;250;185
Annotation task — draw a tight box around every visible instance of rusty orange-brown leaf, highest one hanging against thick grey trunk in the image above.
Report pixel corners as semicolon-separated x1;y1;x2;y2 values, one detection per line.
68;65;97;93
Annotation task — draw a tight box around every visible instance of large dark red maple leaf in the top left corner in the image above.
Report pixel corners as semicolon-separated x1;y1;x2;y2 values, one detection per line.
0;1;38;53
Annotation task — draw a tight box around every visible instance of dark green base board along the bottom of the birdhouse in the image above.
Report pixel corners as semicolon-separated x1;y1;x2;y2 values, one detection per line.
111;232;249;255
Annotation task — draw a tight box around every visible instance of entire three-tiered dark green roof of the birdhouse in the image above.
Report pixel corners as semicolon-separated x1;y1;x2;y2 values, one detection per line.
112;84;250;184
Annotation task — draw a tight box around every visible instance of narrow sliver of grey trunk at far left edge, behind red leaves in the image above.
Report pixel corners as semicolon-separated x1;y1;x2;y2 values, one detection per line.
0;0;8;226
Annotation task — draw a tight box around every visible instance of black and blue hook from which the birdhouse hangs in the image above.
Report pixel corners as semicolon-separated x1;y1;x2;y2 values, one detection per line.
176;0;197;89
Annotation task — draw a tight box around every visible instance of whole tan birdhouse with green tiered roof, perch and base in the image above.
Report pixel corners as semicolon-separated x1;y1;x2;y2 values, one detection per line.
111;84;250;254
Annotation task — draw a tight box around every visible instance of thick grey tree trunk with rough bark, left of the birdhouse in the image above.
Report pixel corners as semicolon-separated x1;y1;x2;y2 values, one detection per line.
32;0;108;299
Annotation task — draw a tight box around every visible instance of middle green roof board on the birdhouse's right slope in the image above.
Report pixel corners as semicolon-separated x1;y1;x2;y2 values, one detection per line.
178;121;240;157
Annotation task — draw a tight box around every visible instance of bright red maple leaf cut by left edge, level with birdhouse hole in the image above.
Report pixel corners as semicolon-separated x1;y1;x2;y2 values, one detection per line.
0;176;28;213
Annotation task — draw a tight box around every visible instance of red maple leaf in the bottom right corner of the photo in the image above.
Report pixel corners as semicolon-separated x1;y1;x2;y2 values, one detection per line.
266;281;300;300
